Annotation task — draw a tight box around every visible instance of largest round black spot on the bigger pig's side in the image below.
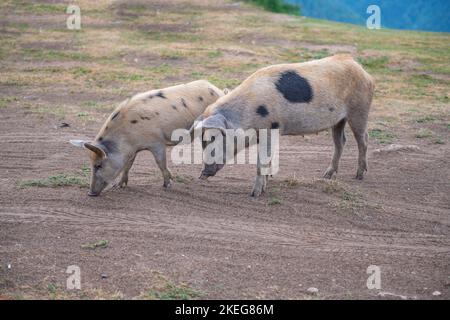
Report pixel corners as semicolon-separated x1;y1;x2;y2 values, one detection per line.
275;71;313;103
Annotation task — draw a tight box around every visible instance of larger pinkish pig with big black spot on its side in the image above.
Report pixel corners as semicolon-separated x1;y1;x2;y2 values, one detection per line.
195;54;374;197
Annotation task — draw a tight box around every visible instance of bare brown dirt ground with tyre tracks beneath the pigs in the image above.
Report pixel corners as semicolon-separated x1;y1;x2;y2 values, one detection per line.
0;0;450;299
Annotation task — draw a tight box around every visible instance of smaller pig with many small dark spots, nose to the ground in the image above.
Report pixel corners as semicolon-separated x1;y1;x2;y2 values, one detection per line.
70;80;224;196
